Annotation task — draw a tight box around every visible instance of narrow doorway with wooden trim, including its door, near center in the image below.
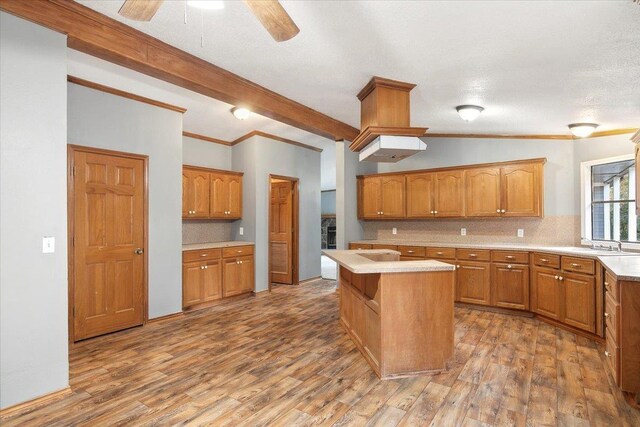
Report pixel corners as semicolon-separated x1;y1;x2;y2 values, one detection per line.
269;175;299;289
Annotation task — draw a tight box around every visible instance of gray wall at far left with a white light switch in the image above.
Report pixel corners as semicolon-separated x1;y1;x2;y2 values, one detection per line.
0;13;69;408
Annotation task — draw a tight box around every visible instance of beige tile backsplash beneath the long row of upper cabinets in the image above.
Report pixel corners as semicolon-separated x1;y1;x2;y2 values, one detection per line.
364;215;580;246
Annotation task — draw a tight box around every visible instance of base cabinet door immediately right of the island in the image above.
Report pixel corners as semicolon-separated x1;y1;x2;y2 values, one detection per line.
456;262;491;305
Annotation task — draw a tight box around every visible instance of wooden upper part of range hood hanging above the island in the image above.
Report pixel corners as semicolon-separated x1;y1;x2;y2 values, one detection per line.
349;77;427;152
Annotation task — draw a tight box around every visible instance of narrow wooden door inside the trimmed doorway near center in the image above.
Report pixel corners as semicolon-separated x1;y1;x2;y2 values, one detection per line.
269;181;293;285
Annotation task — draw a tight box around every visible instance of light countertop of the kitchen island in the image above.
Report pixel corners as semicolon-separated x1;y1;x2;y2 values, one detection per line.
322;249;455;274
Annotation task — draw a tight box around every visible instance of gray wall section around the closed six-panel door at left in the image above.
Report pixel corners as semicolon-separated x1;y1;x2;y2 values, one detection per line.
68;83;182;318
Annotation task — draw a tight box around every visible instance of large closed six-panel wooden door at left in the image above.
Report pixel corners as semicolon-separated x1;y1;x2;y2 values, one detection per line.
72;150;146;341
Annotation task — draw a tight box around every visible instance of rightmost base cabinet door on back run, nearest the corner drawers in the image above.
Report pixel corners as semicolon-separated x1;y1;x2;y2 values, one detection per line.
561;273;596;333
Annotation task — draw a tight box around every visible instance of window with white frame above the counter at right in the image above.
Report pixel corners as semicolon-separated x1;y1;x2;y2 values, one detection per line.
582;156;640;243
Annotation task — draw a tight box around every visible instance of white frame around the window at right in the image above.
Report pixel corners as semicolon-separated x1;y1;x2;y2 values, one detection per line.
580;153;640;250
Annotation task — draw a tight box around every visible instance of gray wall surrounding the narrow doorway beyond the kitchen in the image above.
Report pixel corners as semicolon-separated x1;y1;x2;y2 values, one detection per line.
232;136;320;292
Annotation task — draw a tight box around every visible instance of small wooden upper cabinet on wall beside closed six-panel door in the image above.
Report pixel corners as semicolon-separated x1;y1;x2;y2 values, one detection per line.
182;166;242;219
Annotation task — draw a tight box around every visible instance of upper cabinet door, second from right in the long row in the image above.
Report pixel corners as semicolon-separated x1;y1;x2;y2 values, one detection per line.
465;168;500;216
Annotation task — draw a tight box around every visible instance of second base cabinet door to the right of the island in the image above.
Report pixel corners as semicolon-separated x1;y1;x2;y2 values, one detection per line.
491;264;529;310
